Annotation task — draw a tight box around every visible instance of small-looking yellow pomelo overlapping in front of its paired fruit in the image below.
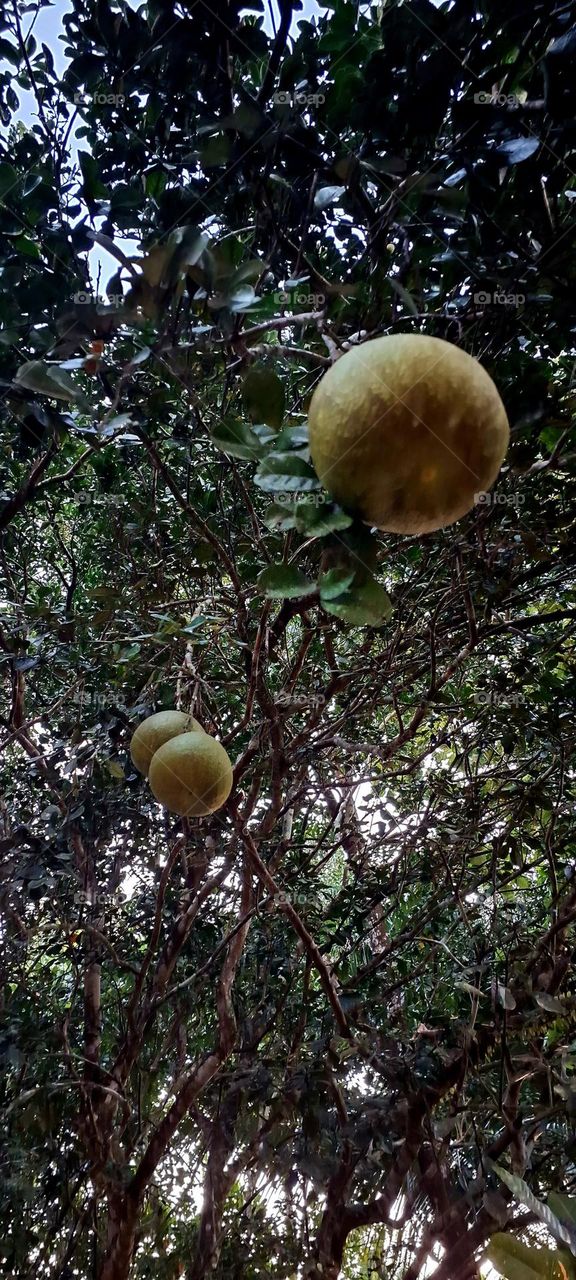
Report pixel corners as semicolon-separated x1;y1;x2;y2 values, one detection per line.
148;731;232;818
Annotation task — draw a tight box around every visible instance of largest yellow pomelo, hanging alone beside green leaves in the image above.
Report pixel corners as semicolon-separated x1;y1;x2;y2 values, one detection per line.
308;333;509;534
